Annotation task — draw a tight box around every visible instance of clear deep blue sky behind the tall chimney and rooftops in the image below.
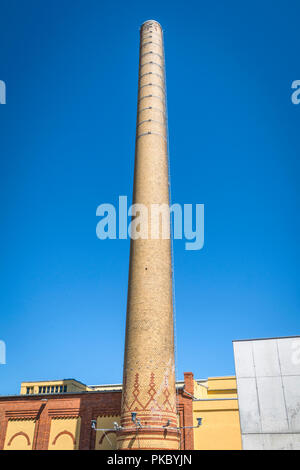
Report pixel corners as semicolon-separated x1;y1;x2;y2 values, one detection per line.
0;0;300;394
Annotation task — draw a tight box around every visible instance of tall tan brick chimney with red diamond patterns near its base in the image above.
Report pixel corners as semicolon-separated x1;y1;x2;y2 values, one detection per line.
117;20;179;449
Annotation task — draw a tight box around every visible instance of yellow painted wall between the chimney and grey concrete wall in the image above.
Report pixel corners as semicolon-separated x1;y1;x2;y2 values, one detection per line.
193;377;242;450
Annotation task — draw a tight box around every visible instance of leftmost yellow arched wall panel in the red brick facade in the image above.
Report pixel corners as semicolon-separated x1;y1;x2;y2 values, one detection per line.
4;419;35;450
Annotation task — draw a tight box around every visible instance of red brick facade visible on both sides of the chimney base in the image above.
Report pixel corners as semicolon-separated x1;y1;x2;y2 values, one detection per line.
0;382;193;450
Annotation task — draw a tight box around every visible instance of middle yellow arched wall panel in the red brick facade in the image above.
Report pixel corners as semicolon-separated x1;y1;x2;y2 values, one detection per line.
48;417;81;450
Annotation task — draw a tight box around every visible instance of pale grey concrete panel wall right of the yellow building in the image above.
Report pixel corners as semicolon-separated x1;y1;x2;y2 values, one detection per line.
233;336;300;450
